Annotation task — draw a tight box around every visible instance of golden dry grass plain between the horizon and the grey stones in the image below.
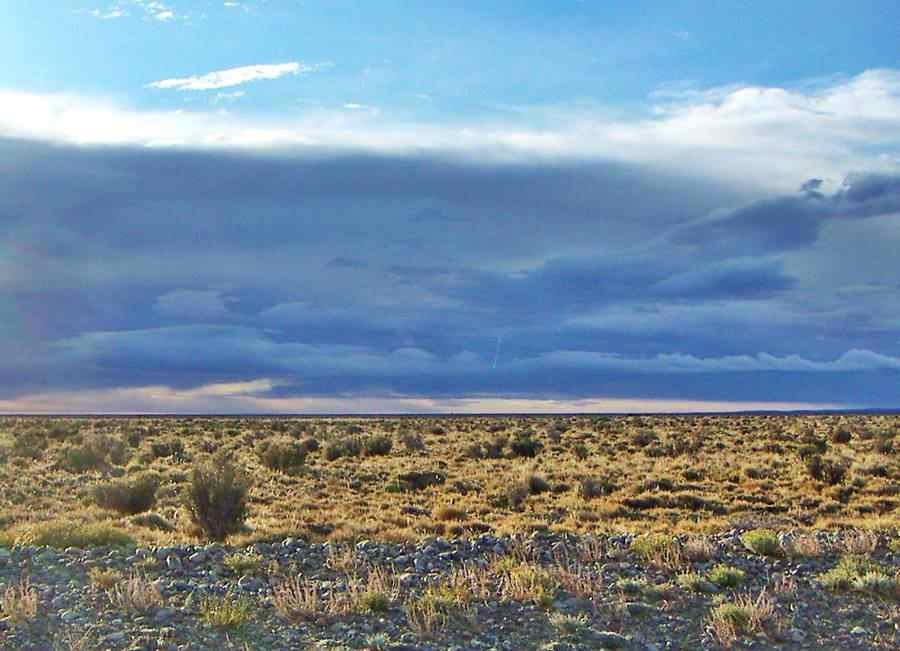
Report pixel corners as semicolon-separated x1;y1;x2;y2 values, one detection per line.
0;415;900;548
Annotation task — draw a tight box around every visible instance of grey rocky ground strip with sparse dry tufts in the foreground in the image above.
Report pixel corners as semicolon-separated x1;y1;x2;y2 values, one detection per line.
0;530;900;651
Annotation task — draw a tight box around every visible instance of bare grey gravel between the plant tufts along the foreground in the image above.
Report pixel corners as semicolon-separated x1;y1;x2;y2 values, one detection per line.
0;530;900;651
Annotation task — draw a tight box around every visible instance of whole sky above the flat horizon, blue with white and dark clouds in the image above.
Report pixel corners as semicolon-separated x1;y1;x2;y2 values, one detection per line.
0;0;900;413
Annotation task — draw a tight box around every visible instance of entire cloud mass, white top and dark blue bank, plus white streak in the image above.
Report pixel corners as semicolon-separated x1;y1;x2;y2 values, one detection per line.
0;69;900;411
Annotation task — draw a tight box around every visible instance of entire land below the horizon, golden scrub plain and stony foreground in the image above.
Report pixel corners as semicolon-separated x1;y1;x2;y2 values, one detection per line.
0;415;900;651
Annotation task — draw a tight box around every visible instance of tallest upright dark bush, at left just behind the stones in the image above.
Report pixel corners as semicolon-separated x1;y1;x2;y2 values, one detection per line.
186;456;250;542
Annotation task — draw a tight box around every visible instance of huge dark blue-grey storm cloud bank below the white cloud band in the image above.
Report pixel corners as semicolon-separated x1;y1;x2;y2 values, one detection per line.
0;140;900;408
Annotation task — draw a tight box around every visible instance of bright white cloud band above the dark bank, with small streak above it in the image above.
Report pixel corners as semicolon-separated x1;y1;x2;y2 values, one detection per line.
0;69;900;192
